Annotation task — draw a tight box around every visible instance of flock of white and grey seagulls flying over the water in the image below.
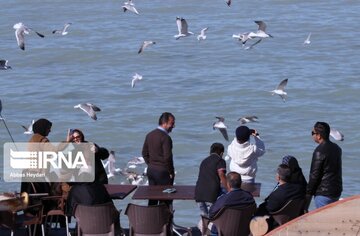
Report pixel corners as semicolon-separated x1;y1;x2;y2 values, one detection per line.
0;0;344;184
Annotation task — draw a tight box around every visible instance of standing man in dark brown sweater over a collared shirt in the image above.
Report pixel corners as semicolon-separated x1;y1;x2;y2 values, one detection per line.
142;112;175;205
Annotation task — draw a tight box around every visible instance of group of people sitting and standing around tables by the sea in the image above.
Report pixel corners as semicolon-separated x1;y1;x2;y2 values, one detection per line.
21;112;342;234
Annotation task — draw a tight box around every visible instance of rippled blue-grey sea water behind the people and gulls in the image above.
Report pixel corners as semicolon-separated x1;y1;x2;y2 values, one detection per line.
0;0;360;227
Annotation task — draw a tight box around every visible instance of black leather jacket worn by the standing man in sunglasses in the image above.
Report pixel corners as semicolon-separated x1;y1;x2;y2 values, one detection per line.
306;140;342;198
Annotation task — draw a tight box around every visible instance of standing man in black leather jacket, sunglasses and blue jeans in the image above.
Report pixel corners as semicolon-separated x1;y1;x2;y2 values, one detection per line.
306;122;342;208
